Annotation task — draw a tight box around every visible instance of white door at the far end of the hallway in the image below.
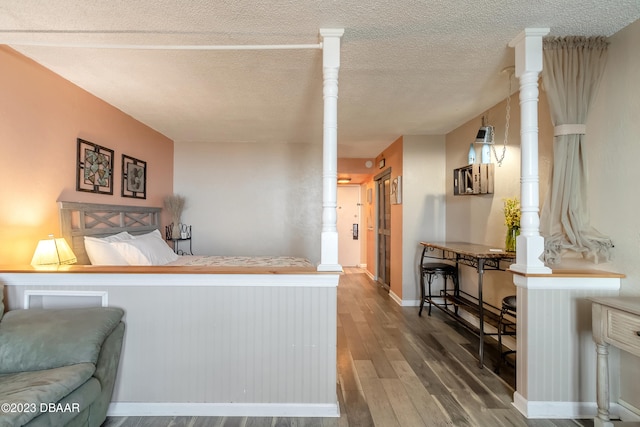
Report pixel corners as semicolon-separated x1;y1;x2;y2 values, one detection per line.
337;186;362;267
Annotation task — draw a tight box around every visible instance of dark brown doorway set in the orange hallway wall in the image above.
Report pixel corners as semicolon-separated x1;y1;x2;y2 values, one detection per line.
375;169;391;290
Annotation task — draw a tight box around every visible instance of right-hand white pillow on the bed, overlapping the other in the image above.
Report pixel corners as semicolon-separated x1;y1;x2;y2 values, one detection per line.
110;230;180;265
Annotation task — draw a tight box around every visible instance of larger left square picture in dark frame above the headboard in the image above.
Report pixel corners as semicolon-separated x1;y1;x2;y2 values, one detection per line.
76;138;113;195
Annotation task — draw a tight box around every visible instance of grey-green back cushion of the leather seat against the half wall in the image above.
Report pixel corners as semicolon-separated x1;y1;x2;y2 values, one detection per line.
0;307;124;374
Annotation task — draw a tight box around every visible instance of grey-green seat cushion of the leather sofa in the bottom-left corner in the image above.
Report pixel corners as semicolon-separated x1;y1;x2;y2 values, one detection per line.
0;363;100;426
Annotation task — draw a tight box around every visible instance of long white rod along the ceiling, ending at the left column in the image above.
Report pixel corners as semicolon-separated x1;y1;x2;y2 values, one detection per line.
0;41;322;50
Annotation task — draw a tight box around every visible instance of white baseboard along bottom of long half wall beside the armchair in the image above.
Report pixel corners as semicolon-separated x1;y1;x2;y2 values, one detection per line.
107;402;340;417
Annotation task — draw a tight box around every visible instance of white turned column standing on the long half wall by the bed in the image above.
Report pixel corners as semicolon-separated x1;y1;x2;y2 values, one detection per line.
318;28;344;271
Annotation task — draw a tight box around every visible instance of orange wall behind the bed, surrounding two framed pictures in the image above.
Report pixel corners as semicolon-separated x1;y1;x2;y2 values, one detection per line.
0;46;173;264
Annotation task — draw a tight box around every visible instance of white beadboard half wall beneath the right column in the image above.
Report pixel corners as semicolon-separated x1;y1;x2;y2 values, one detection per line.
514;274;620;418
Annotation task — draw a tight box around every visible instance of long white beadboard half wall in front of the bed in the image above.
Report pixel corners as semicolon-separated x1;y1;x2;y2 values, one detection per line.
0;274;339;416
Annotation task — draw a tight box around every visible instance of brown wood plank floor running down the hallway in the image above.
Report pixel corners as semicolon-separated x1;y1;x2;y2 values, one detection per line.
103;269;593;427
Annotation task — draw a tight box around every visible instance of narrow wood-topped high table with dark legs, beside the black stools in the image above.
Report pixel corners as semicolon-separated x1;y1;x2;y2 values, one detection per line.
420;242;515;368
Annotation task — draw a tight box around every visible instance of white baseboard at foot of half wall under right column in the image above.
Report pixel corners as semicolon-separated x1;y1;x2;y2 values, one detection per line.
513;392;640;421
